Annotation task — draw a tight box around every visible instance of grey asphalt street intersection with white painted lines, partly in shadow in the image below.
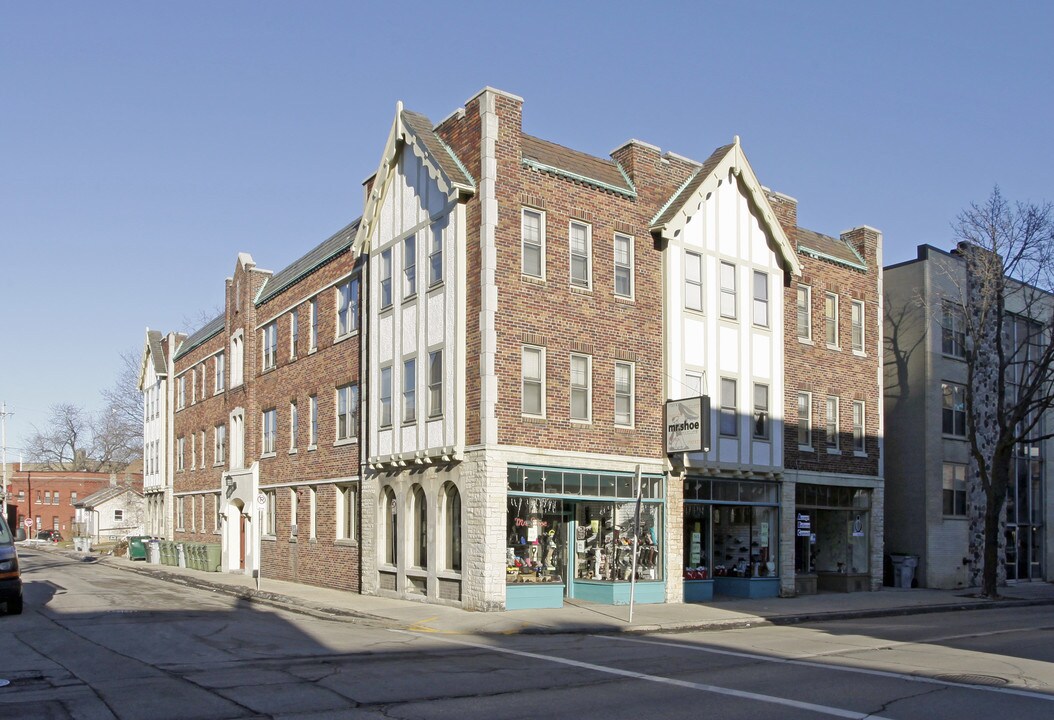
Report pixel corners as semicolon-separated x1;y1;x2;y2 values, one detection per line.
6;548;1054;720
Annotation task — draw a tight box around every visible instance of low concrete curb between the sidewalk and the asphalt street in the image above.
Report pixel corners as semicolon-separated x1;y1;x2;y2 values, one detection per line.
41;548;1054;636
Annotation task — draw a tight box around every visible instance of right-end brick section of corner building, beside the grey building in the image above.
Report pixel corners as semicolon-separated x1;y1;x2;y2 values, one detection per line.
769;193;885;595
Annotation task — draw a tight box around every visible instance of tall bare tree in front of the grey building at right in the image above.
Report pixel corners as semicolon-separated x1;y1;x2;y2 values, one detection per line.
944;188;1054;598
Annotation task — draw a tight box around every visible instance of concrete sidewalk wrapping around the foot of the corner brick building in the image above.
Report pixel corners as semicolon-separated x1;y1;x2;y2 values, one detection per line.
45;546;1054;635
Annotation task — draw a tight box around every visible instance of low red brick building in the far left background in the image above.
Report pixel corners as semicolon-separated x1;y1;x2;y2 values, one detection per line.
7;464;142;538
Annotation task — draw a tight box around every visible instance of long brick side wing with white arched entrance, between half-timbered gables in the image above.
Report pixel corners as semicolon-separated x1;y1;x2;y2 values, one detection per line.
174;222;359;590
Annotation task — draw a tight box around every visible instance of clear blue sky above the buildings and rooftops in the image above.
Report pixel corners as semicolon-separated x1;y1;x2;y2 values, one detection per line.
0;0;1054;460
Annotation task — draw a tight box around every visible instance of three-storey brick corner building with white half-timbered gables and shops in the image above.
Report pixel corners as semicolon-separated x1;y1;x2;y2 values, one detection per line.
152;89;882;610
